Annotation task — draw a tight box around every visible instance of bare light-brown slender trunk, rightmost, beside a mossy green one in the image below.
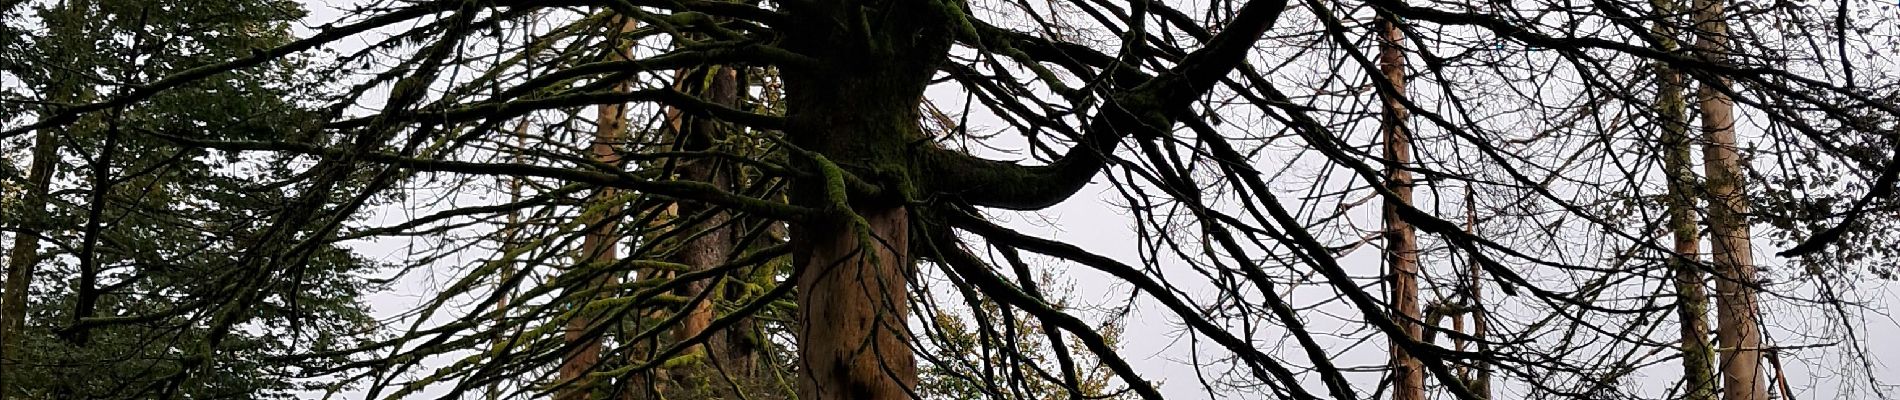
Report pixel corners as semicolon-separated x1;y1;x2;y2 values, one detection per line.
1695;0;1769;400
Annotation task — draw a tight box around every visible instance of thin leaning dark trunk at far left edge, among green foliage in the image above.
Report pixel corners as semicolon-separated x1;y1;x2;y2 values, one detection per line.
0;129;59;398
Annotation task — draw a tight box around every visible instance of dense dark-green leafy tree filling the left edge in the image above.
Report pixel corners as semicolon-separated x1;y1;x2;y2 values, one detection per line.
0;0;374;398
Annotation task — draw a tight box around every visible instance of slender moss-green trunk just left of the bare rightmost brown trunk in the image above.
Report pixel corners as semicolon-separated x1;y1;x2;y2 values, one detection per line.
1651;0;1716;400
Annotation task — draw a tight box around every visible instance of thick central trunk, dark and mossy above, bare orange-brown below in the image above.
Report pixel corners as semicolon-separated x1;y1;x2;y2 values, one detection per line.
783;2;952;400
